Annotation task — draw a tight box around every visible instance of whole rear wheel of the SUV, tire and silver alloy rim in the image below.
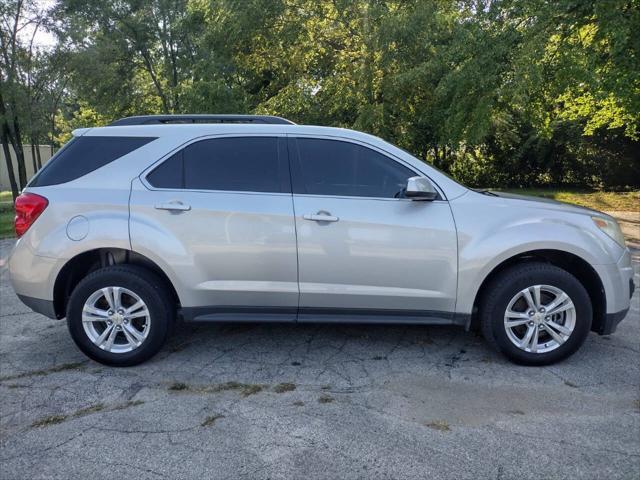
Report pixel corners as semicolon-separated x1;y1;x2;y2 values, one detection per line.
67;265;175;366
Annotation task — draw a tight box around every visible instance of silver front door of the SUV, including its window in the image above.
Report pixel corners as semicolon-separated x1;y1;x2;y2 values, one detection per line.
289;137;457;323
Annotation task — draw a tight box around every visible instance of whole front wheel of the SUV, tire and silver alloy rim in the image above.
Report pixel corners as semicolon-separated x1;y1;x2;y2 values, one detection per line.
479;262;592;365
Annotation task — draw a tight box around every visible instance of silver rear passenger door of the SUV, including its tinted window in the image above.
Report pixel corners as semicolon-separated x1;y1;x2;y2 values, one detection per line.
130;136;298;321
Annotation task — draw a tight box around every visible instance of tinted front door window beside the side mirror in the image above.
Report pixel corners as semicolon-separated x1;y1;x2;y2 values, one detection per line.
294;138;416;198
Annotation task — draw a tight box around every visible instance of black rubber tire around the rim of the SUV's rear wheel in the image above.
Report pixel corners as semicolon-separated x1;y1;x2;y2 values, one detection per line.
67;265;175;367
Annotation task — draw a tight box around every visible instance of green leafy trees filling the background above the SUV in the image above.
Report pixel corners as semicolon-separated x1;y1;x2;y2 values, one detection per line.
3;0;640;187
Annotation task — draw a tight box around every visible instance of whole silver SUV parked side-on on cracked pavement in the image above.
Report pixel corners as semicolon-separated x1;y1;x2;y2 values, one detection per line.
9;116;634;366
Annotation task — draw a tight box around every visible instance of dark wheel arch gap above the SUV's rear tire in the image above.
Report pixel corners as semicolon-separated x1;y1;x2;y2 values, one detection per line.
53;248;180;318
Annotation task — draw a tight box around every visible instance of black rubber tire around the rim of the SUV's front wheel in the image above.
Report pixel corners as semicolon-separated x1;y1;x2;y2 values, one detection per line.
479;262;593;365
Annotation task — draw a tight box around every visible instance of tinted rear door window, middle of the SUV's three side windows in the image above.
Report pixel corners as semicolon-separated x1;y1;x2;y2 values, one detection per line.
147;137;290;193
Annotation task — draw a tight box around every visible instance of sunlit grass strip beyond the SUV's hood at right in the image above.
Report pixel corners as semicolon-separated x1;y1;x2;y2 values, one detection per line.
496;188;640;212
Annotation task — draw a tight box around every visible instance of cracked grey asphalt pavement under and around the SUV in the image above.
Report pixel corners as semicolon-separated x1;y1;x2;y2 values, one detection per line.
0;240;640;480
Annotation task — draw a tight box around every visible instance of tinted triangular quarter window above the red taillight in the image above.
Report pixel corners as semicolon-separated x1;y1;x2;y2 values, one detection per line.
29;136;155;187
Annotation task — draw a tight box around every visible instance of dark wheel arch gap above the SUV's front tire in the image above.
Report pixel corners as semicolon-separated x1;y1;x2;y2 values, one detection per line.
468;249;607;332
